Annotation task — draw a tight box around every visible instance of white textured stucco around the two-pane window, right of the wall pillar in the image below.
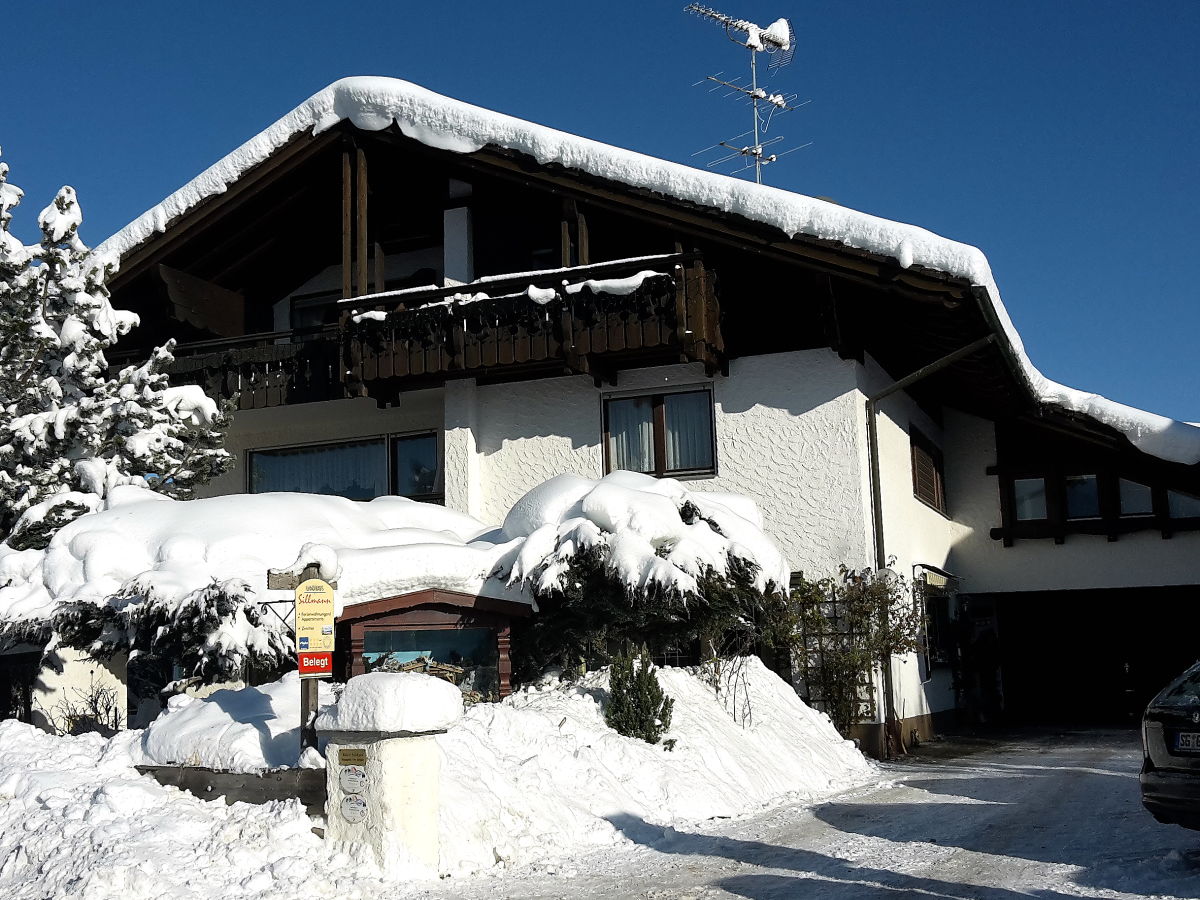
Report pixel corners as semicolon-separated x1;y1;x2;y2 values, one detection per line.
476;350;869;576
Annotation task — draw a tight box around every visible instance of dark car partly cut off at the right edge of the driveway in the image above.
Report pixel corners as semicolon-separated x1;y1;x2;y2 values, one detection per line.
1141;662;1200;829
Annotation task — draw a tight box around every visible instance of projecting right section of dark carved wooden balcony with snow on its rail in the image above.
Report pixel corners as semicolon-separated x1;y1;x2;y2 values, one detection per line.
342;253;725;396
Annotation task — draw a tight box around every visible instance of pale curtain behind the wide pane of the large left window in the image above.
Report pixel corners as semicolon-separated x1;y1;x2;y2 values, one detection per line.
250;440;388;500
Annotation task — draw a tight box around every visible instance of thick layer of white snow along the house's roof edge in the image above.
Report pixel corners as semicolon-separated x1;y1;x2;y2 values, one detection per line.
97;77;1200;464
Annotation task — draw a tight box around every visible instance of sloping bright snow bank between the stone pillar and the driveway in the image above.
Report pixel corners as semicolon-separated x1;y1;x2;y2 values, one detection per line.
438;658;875;872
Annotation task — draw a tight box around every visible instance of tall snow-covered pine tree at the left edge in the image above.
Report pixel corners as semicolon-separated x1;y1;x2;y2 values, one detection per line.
0;153;233;548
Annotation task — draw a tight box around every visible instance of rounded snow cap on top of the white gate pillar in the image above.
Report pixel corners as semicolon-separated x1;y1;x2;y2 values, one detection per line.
317;672;462;732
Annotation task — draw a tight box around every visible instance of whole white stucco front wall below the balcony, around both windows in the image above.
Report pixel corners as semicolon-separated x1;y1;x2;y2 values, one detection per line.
198;350;873;577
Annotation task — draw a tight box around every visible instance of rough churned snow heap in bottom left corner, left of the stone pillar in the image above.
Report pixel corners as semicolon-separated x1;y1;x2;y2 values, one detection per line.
0;720;397;900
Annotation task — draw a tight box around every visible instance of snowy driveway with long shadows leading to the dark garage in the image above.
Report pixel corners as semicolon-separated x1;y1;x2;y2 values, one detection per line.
412;732;1200;900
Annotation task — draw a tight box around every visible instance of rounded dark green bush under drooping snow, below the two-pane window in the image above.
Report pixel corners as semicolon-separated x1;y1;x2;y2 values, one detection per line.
504;472;788;682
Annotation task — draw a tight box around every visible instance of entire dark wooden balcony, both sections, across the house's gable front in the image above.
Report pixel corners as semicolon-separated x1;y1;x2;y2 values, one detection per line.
124;253;725;409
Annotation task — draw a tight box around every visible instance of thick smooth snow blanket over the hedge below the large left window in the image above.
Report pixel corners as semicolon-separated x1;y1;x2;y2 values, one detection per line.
0;487;520;628
